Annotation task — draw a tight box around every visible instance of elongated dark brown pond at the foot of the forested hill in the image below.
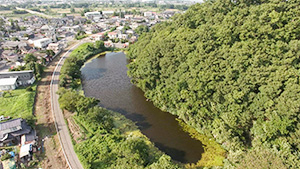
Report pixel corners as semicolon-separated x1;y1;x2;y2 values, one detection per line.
81;53;203;163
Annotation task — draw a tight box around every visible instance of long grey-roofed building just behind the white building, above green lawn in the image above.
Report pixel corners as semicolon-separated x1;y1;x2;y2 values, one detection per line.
0;70;35;86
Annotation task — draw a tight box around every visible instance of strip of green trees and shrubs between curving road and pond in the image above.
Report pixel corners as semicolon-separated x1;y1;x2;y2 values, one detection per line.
58;41;181;169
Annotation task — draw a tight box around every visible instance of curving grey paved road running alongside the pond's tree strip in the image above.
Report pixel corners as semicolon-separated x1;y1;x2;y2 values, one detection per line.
50;41;84;169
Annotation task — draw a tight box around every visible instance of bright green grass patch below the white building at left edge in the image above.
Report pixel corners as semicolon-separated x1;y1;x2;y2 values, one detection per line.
0;85;36;123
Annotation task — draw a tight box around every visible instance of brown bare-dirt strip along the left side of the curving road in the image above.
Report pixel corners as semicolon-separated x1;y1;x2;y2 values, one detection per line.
34;46;75;169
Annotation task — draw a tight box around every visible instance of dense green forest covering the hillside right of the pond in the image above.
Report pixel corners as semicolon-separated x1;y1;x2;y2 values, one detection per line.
127;0;300;168
